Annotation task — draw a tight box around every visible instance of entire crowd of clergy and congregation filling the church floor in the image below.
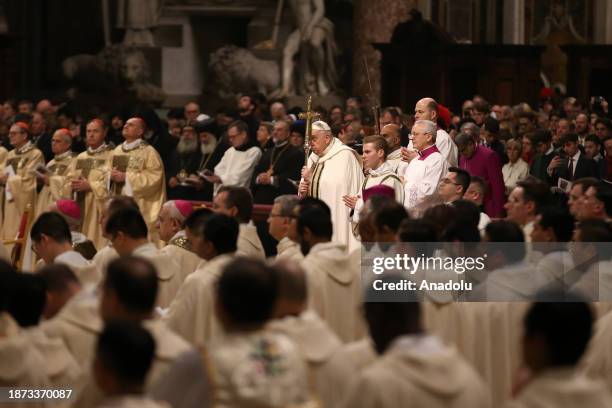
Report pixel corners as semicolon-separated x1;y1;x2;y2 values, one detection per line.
0;90;612;407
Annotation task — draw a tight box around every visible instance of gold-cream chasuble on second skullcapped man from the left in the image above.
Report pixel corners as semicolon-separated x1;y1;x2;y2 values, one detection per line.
35;151;74;217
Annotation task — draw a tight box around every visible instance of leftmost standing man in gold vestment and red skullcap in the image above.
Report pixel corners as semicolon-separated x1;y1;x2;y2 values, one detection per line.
0;122;45;252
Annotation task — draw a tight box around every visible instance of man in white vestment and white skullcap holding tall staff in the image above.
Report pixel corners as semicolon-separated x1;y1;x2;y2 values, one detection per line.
299;121;363;251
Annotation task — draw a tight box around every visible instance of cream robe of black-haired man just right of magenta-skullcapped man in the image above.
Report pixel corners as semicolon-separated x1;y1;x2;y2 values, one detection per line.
163;254;233;346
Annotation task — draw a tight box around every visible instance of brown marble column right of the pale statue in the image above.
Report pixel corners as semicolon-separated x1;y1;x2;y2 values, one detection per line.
352;0;424;104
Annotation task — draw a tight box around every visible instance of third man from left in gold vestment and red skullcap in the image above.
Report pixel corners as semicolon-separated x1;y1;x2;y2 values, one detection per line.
65;119;113;250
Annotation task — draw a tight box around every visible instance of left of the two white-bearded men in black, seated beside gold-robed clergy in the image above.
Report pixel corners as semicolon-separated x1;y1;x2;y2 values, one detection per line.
165;125;203;200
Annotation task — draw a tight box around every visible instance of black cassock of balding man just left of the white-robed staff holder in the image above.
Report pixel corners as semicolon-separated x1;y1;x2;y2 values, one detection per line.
251;142;304;204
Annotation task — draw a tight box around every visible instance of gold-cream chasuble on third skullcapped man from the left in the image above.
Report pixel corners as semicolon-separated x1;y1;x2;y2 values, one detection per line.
64;144;113;250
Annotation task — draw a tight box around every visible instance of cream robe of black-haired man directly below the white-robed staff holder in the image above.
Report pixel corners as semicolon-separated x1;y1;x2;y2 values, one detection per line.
302;242;365;343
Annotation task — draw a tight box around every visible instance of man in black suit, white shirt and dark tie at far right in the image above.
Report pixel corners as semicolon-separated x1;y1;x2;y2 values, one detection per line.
548;133;600;186
